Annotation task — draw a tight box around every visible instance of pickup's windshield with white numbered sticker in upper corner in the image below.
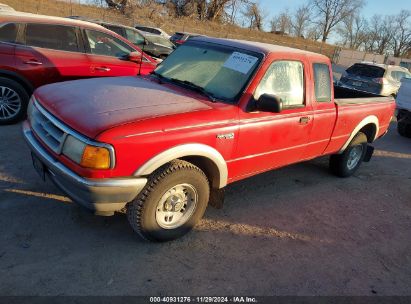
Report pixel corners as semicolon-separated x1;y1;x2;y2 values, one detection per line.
155;42;263;102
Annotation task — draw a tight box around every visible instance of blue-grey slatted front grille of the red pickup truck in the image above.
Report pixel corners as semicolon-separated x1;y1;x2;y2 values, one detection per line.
29;104;67;154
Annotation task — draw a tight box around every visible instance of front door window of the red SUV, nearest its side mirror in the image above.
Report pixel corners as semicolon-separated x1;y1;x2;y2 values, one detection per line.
85;30;134;58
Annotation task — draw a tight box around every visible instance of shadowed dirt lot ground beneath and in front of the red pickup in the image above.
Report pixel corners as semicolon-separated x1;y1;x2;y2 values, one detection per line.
0;121;411;295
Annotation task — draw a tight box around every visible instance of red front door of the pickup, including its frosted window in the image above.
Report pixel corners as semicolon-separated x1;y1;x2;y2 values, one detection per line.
230;60;313;178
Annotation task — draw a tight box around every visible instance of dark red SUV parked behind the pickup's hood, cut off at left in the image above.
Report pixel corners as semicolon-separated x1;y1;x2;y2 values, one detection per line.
0;13;157;124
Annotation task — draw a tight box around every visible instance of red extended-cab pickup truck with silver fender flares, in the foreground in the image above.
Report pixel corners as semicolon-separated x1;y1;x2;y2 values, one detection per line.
23;37;395;241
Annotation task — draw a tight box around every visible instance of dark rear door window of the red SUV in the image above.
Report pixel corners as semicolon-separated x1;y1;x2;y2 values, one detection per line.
25;23;79;52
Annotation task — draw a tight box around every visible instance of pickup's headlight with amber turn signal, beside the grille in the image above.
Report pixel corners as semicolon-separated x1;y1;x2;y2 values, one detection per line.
63;135;111;169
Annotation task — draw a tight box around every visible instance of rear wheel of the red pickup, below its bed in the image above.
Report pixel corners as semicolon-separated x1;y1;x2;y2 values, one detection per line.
330;132;367;177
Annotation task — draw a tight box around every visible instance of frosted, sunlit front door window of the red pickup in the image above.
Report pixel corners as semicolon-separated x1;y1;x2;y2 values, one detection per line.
254;61;304;107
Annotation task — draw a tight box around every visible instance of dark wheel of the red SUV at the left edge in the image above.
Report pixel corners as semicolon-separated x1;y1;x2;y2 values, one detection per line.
0;77;29;125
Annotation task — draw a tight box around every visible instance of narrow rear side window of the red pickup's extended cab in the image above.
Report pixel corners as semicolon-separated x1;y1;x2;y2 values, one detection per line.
313;63;331;102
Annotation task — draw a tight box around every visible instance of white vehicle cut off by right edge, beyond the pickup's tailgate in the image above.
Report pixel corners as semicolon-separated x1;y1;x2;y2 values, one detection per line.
396;78;411;137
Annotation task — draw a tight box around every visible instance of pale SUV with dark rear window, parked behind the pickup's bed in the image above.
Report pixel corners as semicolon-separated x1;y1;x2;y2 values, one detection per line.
339;63;411;96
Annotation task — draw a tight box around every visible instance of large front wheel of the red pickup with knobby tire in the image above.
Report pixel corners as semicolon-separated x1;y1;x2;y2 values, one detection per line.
127;160;210;242
